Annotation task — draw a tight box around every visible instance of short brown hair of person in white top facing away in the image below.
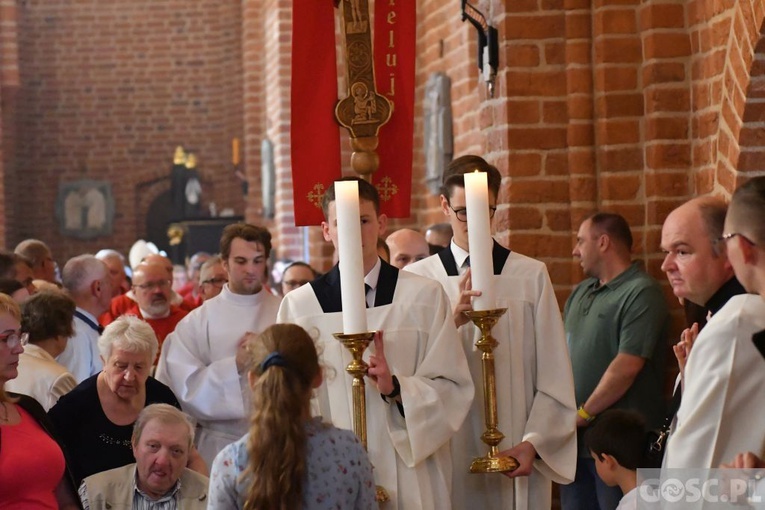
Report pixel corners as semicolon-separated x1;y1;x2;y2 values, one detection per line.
21;290;76;343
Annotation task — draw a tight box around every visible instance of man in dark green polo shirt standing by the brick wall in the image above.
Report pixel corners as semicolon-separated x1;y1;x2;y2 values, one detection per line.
561;212;669;510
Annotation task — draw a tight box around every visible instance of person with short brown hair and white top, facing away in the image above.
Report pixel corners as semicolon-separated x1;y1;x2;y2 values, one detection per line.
6;290;77;411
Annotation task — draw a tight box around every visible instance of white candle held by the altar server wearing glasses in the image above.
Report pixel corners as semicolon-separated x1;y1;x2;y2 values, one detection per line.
465;172;496;310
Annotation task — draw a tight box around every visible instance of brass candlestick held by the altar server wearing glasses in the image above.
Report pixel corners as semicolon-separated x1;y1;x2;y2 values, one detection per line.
463;308;518;473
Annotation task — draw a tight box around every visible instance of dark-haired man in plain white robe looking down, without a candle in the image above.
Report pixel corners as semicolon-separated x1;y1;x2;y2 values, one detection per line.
156;223;280;466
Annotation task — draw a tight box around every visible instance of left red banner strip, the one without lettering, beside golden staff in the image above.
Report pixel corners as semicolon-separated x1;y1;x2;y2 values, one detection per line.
290;0;341;226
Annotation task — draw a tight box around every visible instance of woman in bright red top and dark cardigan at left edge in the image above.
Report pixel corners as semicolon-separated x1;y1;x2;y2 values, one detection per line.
0;294;79;509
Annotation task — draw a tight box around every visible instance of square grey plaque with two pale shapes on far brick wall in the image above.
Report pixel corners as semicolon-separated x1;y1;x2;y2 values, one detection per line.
56;179;114;239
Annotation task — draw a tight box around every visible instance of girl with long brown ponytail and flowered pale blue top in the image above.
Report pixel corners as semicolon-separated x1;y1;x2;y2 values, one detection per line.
208;324;377;510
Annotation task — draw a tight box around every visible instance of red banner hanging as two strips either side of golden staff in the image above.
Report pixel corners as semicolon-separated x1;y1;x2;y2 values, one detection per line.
290;0;417;225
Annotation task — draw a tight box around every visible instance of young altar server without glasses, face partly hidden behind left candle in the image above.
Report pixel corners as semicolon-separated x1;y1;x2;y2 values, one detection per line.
278;176;474;510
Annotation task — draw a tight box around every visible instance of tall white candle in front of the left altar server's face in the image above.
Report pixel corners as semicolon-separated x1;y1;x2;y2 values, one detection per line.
335;181;367;334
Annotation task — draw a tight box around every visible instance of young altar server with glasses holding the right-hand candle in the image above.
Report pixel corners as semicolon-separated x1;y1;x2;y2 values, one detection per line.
406;156;576;510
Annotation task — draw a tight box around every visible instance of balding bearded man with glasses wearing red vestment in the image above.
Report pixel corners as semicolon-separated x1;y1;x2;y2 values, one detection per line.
105;262;188;359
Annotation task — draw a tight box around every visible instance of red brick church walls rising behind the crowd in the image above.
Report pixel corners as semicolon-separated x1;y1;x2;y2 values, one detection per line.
5;0;765;282
